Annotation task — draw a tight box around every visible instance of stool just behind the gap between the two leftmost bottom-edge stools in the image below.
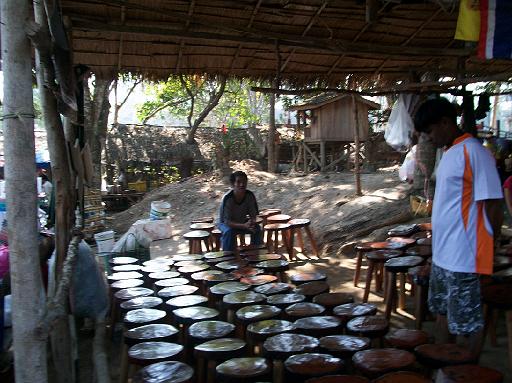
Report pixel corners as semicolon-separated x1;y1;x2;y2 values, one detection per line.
194;338;246;383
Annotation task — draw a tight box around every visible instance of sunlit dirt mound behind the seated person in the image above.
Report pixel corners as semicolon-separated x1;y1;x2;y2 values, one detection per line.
111;160;410;252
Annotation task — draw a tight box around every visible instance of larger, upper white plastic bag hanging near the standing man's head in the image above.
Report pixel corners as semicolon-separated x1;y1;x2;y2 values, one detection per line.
384;97;414;150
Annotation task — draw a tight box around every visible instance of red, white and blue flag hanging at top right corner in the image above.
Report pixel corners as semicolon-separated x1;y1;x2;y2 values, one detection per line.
478;0;512;59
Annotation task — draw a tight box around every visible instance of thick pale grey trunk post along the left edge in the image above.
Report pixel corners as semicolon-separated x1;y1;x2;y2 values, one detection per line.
1;0;48;383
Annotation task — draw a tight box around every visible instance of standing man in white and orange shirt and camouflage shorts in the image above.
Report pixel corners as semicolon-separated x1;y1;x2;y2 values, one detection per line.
414;98;503;358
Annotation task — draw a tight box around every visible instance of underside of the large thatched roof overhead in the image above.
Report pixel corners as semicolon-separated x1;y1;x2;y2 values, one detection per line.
61;0;512;86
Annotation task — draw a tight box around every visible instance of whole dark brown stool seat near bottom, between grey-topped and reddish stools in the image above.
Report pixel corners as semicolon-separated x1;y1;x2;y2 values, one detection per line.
352;348;416;378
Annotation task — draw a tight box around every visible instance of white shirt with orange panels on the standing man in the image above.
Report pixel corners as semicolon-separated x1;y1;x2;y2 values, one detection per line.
432;133;503;274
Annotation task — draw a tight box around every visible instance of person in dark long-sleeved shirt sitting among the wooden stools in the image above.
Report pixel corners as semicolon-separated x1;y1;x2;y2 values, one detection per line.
219;171;261;251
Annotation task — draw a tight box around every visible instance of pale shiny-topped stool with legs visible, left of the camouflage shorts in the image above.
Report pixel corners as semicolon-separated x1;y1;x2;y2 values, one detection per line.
384;255;424;319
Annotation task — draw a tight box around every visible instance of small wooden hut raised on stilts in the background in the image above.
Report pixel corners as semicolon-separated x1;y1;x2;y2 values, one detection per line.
290;93;380;172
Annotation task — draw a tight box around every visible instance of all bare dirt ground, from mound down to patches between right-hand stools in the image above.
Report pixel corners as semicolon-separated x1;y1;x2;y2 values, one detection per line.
106;161;512;382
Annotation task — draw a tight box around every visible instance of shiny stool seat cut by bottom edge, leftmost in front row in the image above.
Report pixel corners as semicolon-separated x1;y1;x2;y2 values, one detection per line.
132;361;194;383
